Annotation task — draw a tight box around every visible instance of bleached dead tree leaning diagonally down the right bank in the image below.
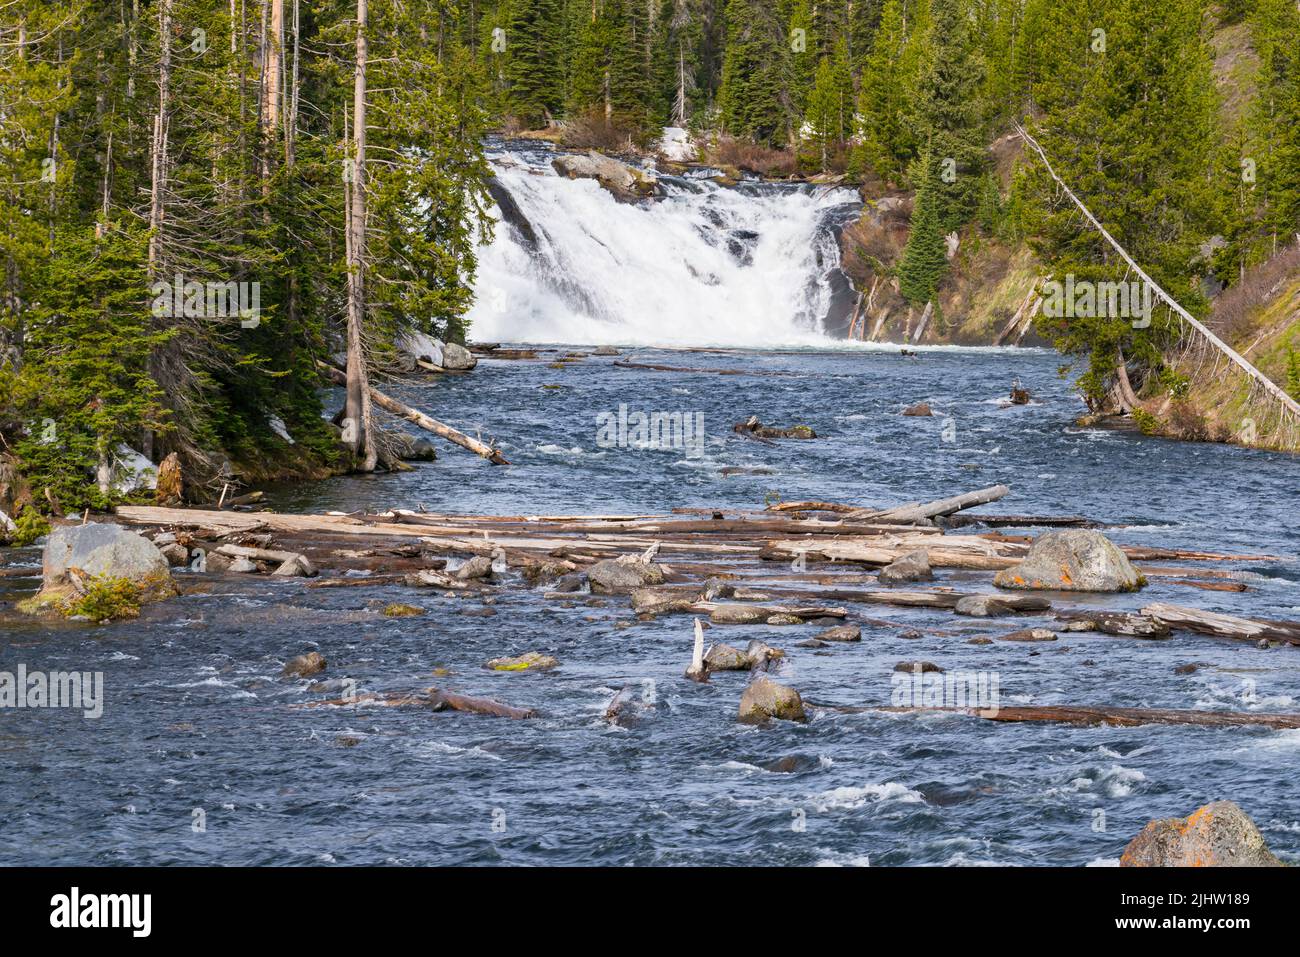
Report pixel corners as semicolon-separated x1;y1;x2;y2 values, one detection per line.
1015;124;1300;451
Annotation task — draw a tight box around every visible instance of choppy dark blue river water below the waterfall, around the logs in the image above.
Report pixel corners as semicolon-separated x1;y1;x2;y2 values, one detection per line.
0;350;1300;865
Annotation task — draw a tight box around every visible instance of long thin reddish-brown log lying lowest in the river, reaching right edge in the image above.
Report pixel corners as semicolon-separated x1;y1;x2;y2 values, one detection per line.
805;701;1300;729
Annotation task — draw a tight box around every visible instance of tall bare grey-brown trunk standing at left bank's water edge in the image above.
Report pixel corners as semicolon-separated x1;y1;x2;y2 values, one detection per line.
343;0;378;472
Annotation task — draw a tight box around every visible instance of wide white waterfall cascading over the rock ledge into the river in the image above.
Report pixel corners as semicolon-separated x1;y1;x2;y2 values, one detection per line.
469;147;858;348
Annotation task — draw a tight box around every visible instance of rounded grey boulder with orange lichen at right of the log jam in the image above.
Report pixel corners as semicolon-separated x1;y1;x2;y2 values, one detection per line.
993;528;1147;592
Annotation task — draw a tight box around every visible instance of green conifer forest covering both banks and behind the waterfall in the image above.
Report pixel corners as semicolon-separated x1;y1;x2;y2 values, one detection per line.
0;0;1300;522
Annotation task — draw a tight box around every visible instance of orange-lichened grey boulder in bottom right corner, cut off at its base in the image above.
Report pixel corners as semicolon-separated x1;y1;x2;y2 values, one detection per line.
1119;801;1283;867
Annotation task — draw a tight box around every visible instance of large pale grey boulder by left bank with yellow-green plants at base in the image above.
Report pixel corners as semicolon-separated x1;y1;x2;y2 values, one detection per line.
25;523;176;611
